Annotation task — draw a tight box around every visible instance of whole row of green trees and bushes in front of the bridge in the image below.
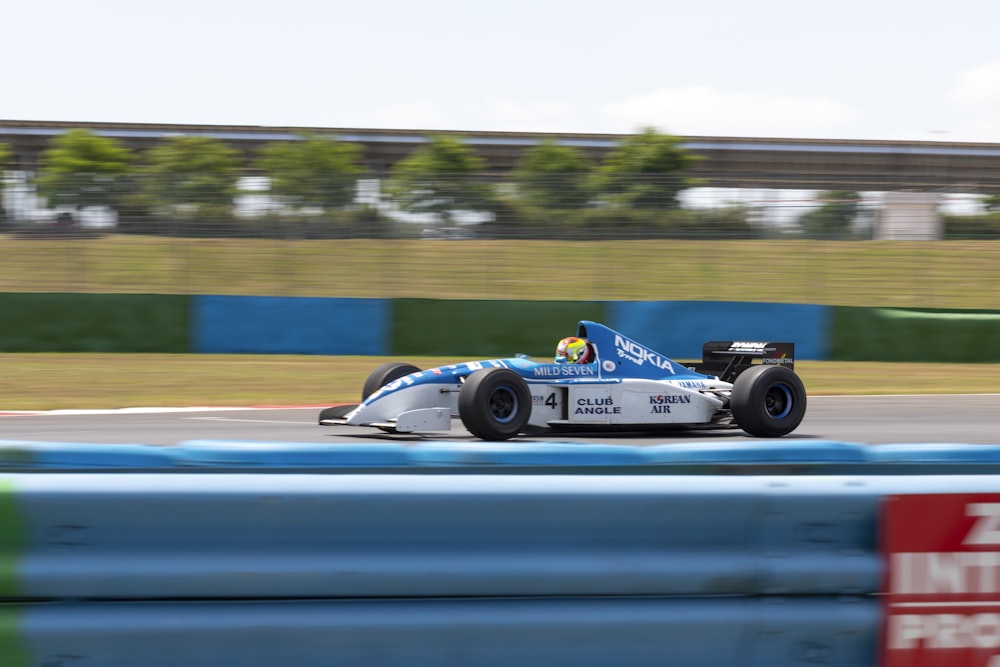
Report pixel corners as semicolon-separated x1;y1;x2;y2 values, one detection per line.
0;128;1000;238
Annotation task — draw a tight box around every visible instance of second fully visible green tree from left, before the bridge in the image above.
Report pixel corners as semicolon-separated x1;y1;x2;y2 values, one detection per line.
146;136;240;214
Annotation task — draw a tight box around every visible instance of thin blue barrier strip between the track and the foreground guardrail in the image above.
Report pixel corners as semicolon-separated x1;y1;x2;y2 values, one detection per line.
0;438;1000;475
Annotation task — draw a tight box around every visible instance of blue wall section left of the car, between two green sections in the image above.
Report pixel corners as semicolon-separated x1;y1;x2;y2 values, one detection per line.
192;295;391;355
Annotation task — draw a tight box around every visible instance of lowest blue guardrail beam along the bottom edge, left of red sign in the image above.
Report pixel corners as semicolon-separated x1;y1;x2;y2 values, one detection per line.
0;598;878;667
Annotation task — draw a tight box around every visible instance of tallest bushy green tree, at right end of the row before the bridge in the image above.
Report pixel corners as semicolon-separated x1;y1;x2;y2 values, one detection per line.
595;128;699;209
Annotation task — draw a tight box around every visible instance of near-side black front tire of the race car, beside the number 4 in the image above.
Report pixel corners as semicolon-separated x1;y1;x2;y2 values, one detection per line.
458;368;531;441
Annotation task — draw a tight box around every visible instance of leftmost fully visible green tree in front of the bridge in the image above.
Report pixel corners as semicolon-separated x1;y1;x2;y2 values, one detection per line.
36;129;133;207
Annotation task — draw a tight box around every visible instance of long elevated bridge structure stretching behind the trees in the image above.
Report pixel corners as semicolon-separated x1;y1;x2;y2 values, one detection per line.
0;120;1000;194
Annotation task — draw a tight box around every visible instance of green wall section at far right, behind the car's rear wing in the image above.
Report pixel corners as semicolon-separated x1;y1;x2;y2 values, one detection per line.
829;307;1000;363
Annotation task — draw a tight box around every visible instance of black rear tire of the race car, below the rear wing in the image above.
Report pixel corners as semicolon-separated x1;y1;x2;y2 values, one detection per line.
729;365;806;438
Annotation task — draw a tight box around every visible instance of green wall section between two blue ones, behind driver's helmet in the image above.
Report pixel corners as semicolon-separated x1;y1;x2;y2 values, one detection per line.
390;299;606;358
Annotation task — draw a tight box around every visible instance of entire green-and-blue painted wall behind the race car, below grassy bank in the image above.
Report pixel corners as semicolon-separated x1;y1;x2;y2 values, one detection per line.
9;294;1000;363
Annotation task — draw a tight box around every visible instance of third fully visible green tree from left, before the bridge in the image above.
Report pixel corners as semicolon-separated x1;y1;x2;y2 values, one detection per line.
258;136;364;209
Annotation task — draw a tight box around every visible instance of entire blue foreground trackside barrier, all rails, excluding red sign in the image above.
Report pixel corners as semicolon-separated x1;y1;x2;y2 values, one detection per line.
0;448;1000;667
